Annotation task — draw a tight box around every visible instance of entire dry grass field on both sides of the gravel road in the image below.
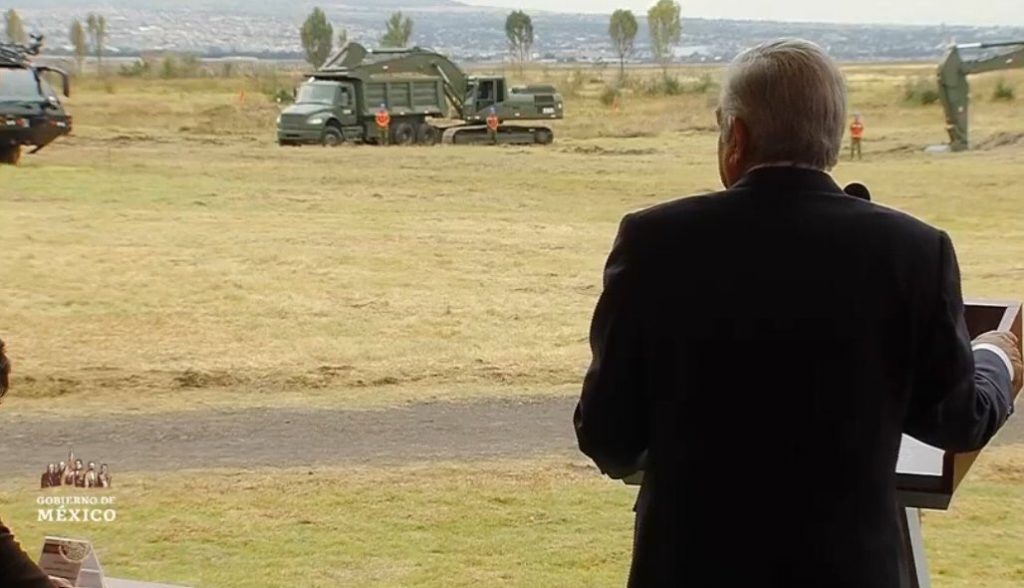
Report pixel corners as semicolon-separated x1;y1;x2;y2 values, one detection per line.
0;66;1024;588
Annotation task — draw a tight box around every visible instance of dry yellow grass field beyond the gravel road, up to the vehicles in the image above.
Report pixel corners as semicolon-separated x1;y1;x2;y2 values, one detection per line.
0;67;1024;412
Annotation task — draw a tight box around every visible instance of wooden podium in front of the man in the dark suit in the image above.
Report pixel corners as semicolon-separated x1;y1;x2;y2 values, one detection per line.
623;300;1024;588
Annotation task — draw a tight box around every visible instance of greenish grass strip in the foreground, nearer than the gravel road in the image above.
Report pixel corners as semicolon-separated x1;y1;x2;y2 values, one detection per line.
0;447;1024;588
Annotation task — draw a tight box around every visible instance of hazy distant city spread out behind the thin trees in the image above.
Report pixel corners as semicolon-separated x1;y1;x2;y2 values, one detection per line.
22;7;1024;62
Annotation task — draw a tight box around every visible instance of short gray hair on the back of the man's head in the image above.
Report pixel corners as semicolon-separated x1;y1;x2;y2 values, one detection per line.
719;39;847;170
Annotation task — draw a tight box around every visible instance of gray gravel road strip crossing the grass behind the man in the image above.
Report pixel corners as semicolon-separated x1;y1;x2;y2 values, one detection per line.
0;397;1024;475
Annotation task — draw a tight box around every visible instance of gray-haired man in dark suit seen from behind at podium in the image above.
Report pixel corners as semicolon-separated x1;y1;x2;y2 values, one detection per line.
573;40;1022;588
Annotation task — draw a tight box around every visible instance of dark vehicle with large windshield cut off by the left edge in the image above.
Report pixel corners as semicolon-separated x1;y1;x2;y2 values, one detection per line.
0;36;72;165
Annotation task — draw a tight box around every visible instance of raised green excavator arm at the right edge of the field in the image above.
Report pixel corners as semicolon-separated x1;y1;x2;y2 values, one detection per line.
939;41;1024;152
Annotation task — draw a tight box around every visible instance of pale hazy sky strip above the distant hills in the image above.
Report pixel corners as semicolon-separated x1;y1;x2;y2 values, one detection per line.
462;0;1024;27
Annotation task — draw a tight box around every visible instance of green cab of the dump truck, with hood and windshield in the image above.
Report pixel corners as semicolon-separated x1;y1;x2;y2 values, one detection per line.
278;80;360;145
